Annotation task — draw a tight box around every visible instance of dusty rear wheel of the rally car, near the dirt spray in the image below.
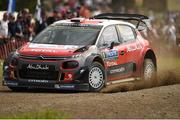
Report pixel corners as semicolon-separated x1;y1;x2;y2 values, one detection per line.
142;59;157;87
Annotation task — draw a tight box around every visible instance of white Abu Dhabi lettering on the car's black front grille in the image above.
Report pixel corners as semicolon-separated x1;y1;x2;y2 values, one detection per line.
27;64;49;70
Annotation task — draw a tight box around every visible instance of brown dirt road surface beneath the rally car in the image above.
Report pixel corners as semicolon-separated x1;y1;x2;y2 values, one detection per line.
0;80;180;118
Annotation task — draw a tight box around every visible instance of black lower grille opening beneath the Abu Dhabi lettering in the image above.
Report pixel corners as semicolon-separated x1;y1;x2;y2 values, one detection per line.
19;65;58;80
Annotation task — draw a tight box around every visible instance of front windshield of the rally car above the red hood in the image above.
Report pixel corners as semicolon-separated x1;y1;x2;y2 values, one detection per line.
32;26;101;46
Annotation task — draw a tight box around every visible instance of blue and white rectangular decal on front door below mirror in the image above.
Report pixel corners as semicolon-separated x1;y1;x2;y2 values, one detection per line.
103;50;118;60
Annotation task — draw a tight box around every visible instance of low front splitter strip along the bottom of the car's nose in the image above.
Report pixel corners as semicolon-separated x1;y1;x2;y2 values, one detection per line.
3;80;89;91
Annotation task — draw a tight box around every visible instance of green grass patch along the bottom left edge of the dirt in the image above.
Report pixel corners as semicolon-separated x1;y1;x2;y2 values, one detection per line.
0;109;70;119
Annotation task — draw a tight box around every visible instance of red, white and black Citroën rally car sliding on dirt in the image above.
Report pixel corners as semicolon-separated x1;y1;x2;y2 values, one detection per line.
3;13;157;91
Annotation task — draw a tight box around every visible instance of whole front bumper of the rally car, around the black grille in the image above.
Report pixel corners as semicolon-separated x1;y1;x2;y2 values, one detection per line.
3;55;89;91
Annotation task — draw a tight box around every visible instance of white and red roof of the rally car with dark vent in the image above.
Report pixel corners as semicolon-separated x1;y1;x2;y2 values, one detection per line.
52;18;136;28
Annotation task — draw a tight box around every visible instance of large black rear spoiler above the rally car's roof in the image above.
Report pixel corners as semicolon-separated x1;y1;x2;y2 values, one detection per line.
91;13;151;29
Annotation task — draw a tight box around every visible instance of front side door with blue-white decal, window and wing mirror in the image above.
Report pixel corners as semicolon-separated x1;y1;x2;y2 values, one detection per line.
99;26;130;81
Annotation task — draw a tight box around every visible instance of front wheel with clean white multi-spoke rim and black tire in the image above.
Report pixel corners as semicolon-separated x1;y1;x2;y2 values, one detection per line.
88;62;105;92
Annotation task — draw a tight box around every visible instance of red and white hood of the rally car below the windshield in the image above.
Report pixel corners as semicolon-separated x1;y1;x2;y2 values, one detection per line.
18;43;83;56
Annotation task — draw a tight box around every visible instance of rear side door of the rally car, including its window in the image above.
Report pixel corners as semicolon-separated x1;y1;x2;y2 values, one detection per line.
117;25;142;77
